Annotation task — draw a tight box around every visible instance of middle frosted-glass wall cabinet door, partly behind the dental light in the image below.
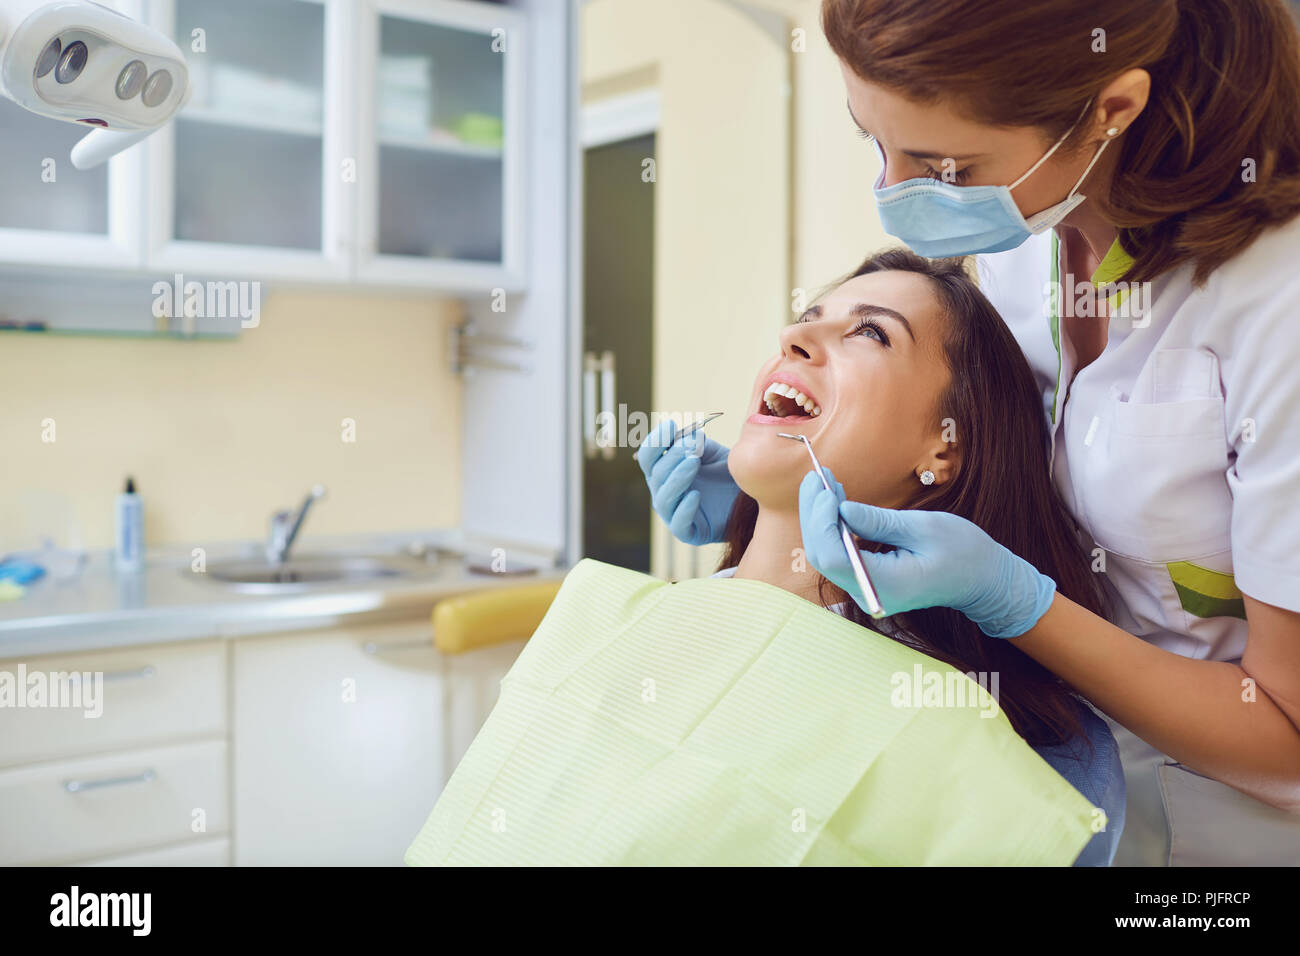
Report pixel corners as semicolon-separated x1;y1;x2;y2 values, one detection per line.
151;0;338;273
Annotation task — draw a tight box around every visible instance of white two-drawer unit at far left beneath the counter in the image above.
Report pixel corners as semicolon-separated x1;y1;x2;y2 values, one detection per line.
0;640;230;866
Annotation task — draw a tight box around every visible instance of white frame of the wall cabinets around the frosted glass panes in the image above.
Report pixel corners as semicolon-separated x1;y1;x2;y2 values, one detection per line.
0;0;527;294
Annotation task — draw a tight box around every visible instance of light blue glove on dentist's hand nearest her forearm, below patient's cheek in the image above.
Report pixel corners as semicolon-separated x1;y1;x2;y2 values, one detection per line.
800;466;1056;637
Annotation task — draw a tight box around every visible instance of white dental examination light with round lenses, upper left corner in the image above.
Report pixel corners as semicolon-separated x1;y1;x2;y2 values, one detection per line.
0;0;190;169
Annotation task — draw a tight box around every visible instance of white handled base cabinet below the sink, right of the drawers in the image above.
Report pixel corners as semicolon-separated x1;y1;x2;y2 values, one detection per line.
233;619;523;866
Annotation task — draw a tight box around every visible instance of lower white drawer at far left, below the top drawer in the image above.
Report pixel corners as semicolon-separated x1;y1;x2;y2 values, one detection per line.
0;740;230;866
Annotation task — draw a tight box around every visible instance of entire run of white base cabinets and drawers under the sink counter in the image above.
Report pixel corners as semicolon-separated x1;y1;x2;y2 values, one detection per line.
0;617;524;866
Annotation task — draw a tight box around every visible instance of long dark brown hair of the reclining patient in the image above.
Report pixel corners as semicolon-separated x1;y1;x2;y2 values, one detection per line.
718;248;1106;745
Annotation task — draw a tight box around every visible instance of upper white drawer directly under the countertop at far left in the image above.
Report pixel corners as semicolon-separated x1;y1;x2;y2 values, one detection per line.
0;640;226;767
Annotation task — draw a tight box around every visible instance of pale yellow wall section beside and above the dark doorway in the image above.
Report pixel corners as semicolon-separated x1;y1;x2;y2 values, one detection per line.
581;0;789;576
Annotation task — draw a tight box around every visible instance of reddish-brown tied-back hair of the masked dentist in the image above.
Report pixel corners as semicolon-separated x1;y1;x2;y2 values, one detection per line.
822;0;1300;285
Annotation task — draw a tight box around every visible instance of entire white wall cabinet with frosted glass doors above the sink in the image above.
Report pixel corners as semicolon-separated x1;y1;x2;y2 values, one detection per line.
0;0;533;293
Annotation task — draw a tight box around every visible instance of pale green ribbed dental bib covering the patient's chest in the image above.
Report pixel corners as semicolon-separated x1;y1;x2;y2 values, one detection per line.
406;559;1093;866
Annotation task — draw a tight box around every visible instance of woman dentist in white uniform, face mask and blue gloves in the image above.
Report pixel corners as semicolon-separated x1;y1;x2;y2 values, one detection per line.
647;0;1300;866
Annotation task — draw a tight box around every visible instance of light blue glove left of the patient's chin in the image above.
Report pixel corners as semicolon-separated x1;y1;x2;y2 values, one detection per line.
637;419;740;545
